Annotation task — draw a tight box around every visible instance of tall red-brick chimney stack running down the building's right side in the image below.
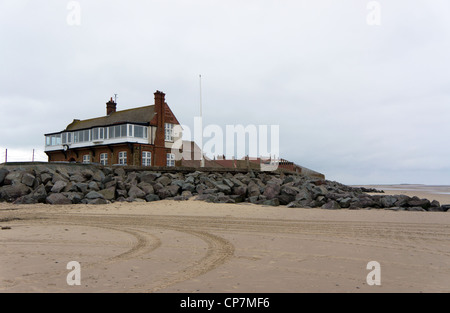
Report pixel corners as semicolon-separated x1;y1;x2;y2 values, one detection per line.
154;90;167;166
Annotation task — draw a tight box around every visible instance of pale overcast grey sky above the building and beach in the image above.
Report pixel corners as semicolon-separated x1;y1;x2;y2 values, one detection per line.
0;0;450;185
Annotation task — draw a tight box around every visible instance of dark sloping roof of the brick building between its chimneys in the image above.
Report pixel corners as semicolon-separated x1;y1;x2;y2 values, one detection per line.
65;105;155;131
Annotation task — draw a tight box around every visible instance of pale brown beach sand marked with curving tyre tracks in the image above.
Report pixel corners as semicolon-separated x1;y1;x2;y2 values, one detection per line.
0;185;450;293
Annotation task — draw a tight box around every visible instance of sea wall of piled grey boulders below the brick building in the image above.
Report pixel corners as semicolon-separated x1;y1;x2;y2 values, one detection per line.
0;163;449;211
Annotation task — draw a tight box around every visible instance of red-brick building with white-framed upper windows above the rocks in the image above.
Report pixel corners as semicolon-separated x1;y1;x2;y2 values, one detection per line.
45;91;182;166
